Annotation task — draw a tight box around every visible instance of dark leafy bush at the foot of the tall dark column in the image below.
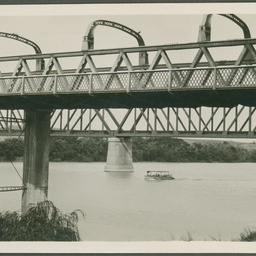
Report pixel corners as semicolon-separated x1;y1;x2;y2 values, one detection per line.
0;201;84;241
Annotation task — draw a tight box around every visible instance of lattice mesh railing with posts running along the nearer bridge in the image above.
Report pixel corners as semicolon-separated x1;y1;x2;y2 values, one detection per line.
0;65;256;95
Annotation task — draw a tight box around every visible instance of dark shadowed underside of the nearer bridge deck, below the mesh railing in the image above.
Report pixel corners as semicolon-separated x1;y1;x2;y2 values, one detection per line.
0;88;256;109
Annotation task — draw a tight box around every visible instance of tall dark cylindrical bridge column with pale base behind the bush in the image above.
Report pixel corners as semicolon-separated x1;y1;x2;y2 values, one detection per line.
21;110;51;213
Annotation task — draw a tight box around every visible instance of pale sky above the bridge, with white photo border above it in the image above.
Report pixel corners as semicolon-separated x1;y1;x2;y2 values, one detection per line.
0;4;256;56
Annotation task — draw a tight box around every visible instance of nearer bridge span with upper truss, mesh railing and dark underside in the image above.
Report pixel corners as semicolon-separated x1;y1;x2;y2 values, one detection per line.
0;39;256;109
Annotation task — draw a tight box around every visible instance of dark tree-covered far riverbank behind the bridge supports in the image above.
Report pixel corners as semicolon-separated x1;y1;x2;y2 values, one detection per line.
0;137;256;163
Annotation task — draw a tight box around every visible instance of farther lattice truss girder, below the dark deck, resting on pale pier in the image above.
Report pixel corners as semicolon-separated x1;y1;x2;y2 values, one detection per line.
0;106;256;138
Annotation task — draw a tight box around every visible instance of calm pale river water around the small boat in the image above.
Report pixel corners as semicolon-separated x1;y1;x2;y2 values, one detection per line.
0;162;256;241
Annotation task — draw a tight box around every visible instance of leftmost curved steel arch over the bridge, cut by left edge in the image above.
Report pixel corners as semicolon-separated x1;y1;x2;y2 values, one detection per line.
0;32;45;71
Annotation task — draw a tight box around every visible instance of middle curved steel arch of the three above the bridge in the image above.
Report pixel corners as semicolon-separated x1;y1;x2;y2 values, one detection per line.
82;20;148;65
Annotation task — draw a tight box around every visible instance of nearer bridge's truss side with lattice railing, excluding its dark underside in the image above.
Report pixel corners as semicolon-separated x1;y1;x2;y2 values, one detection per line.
0;39;256;94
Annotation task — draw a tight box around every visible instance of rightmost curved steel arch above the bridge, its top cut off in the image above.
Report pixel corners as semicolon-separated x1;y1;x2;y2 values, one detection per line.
198;14;251;42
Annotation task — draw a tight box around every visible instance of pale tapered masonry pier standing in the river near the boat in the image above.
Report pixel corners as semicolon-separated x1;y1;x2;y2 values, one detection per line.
105;138;134;172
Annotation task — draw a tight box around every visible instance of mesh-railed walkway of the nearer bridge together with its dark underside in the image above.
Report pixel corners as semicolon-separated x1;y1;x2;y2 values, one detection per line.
0;65;256;109
